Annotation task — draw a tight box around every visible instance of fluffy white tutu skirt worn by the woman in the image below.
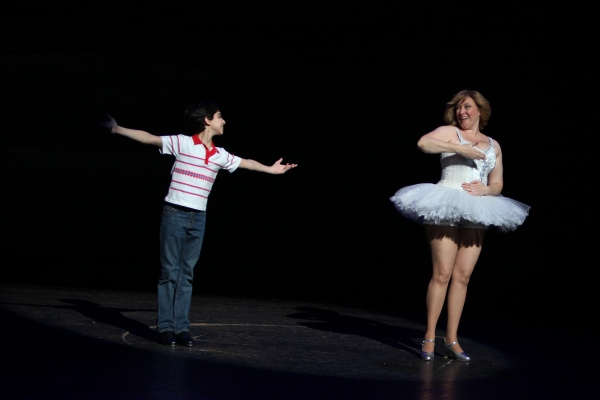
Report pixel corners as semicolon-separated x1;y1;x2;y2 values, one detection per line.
390;183;530;232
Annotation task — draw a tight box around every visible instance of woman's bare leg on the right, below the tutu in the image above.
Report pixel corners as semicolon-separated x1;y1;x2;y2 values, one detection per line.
445;229;485;353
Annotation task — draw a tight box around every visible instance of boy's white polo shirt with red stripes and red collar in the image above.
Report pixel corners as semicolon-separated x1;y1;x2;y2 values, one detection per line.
159;135;242;211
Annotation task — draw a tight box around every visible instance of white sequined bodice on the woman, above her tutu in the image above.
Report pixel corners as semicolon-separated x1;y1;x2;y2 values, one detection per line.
437;128;496;189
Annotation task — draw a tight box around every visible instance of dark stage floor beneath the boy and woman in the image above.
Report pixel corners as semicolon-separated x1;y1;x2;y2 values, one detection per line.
0;285;600;400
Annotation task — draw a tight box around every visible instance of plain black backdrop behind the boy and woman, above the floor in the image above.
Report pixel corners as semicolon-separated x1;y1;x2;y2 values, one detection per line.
0;2;594;332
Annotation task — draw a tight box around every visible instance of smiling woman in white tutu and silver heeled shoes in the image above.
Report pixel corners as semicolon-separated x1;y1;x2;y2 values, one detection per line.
391;90;529;361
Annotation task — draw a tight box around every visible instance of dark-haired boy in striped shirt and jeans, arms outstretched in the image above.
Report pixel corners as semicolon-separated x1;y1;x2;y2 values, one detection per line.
103;103;296;347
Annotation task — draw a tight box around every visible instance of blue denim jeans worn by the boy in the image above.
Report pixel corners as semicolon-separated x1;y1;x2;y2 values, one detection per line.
156;204;206;334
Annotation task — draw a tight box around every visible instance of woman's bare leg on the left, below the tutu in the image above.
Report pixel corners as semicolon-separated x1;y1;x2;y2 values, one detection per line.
423;225;459;352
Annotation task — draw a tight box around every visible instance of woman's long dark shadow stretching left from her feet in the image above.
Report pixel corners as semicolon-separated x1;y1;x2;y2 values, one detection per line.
287;307;423;357
